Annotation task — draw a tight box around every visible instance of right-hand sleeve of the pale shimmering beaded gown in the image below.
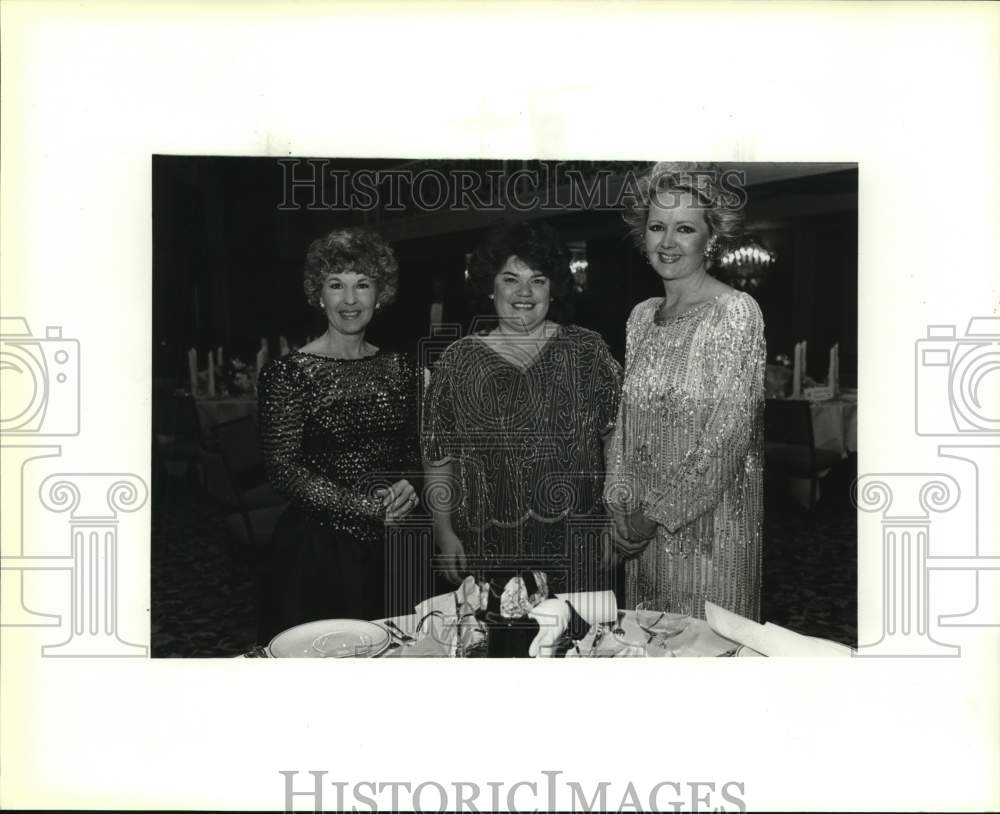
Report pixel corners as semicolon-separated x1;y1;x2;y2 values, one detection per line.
643;295;765;533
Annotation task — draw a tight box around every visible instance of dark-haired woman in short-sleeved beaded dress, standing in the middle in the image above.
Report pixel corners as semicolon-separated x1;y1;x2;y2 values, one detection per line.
422;223;621;591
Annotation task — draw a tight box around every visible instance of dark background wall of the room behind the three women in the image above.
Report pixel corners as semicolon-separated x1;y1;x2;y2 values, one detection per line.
152;156;858;386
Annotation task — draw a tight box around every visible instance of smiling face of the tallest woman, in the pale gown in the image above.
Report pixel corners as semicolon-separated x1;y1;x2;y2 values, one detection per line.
645;190;711;280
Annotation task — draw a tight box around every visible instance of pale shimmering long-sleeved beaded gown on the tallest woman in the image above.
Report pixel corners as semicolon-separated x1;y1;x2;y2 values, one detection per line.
606;292;766;619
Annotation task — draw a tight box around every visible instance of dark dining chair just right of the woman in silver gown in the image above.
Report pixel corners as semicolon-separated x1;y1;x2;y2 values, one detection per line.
764;399;841;510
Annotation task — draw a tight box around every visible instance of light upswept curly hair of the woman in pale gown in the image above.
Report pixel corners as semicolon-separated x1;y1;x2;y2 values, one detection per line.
622;161;744;259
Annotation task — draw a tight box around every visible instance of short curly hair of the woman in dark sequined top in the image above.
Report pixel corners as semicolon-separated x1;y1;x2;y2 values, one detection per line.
302;227;399;310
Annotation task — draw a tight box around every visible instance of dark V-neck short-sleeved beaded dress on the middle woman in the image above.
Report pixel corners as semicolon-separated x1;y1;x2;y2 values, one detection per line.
422;325;621;591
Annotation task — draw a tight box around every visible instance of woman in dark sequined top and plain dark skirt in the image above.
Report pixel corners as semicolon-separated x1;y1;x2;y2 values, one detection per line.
258;229;420;642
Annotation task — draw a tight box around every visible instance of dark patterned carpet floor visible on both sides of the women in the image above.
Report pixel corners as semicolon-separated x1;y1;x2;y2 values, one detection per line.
152;458;857;657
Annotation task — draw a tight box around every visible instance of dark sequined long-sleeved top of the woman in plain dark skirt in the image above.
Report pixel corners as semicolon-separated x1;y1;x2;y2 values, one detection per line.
258;352;420;536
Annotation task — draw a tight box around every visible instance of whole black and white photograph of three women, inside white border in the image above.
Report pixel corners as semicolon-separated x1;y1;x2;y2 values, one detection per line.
151;156;858;658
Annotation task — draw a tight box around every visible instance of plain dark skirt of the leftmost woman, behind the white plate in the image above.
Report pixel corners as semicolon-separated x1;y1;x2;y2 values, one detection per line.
258;506;387;645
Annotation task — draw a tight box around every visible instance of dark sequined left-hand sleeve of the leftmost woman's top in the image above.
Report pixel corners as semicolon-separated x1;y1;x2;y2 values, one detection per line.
258;359;385;520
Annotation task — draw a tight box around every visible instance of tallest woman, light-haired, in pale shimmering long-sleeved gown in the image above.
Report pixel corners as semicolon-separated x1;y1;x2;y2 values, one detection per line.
605;164;765;619
